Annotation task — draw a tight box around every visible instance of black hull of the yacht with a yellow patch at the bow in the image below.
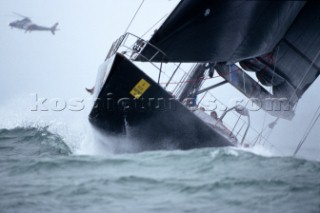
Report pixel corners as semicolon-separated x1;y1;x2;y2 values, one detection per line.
89;53;233;152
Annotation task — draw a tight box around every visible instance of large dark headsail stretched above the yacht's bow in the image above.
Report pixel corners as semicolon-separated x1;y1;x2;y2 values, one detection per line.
136;0;305;63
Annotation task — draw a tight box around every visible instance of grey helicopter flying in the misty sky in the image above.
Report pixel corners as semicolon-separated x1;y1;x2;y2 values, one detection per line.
9;13;59;35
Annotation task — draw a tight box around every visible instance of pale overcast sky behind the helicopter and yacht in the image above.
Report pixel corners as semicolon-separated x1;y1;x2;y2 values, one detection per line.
0;0;320;160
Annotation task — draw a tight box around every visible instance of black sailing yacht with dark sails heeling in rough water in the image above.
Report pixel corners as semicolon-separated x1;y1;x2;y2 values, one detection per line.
89;0;320;152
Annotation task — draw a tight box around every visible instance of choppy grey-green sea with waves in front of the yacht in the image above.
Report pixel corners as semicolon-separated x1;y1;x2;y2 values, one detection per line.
0;125;320;213
